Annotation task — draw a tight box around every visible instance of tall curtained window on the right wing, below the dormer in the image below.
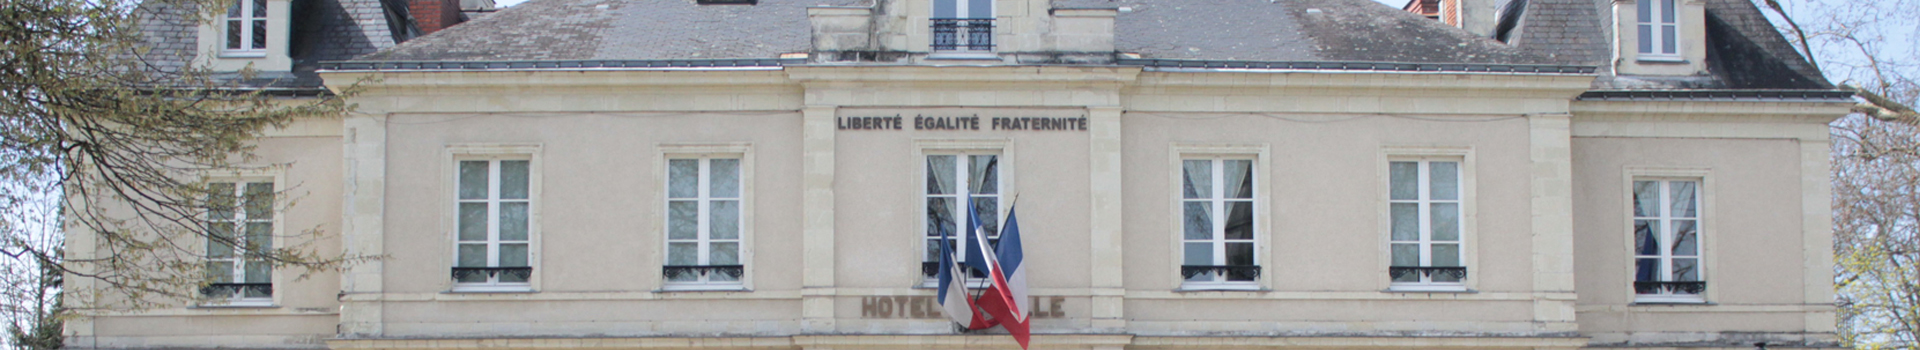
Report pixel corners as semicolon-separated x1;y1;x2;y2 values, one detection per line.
1634;179;1707;302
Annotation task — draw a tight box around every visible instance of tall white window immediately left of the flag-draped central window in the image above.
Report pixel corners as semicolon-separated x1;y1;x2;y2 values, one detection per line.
662;158;745;288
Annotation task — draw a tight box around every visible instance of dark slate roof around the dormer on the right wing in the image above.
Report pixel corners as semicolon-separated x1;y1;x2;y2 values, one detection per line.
1513;0;1834;90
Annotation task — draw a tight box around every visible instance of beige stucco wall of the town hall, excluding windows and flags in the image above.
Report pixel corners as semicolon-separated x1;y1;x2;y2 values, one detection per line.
71;67;1845;348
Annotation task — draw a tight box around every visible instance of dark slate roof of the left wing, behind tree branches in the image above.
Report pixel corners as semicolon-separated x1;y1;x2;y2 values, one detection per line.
134;0;413;90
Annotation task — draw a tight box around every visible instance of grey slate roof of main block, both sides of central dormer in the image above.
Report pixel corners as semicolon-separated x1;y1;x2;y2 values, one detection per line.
359;0;1551;63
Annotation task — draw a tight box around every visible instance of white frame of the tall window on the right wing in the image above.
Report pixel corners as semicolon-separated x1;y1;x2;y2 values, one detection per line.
1622;167;1716;304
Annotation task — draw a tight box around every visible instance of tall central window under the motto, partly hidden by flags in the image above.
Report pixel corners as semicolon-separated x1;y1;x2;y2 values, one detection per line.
922;152;1000;279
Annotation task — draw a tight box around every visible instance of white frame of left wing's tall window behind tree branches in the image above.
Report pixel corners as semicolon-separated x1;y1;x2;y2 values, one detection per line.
200;175;284;308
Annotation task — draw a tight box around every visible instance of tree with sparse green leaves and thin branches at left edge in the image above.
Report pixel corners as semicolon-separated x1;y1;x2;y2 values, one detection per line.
0;0;360;311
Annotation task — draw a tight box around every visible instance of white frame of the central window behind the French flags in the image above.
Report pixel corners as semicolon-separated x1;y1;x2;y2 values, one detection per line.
912;138;1016;288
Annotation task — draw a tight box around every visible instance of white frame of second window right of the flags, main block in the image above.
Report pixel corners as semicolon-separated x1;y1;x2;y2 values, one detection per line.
1379;146;1486;292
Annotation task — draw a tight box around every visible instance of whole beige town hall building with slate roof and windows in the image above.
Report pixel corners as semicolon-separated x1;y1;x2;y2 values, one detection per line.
67;0;1851;350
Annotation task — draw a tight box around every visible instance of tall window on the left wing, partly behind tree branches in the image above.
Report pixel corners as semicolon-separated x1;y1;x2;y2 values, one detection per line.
200;183;275;304
